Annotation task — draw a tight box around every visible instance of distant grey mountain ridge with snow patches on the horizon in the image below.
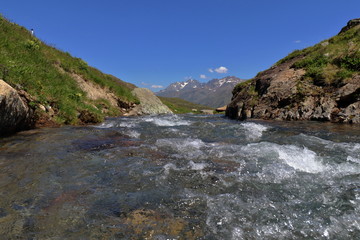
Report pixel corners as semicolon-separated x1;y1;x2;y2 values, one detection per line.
156;76;244;108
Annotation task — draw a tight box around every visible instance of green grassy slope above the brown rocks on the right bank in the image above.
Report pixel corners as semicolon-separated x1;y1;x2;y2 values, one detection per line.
277;25;360;87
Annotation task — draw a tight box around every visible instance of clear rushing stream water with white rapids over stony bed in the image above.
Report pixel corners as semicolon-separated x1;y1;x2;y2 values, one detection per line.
0;115;360;240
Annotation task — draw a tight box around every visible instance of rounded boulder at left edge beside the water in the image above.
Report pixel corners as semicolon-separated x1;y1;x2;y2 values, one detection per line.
0;80;34;135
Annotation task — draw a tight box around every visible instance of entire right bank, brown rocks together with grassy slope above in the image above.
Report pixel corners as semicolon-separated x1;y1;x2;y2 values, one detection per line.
226;19;360;123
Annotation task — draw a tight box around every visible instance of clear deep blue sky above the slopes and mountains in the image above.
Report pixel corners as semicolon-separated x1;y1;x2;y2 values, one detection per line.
0;0;360;91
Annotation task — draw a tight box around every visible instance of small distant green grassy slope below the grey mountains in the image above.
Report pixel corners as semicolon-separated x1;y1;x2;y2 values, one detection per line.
158;96;212;114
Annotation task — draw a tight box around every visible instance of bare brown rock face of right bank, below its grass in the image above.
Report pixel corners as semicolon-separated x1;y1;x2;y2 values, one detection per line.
226;59;360;123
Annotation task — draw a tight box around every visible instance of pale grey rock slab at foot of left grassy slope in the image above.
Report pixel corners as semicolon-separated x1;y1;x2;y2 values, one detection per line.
125;88;173;116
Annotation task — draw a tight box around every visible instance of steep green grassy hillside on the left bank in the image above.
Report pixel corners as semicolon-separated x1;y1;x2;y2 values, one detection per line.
0;16;137;124
